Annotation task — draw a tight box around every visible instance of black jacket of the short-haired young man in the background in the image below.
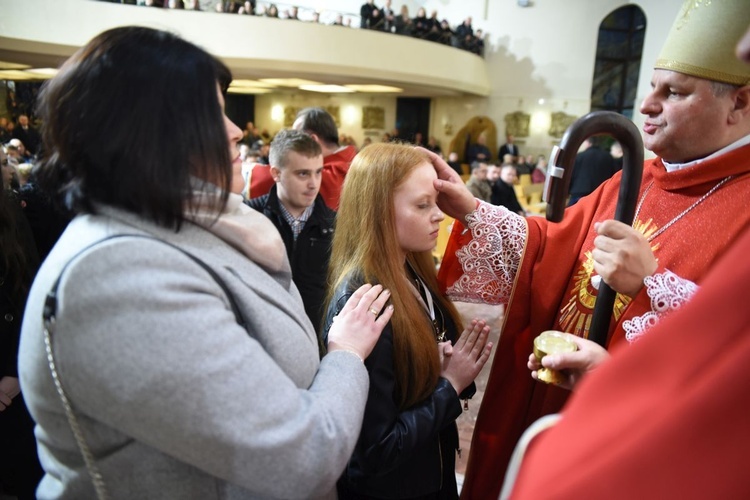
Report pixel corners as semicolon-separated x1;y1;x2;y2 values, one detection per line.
245;185;336;357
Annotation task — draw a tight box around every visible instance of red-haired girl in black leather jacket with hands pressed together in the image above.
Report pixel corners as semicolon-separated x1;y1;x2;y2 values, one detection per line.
326;144;492;500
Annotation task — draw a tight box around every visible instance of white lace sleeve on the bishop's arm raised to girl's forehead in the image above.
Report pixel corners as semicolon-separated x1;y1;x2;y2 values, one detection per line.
448;202;528;304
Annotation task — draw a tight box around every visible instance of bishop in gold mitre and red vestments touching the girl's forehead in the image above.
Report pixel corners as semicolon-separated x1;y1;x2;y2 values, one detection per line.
433;0;750;499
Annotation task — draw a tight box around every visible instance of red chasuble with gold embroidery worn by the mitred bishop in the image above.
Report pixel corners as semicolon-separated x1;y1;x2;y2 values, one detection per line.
439;146;750;499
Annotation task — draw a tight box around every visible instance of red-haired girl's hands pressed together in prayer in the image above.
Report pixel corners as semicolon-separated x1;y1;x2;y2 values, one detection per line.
440;319;492;394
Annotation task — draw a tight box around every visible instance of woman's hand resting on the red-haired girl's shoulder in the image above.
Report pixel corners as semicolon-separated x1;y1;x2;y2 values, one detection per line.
328;284;400;360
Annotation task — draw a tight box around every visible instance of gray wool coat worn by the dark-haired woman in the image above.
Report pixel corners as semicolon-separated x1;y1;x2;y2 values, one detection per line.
19;207;368;499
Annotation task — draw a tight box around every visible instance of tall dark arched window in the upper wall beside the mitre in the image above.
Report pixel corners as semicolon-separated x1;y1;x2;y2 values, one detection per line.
591;5;646;118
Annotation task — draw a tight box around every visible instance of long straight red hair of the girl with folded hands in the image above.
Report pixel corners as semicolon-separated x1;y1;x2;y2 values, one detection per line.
329;143;461;408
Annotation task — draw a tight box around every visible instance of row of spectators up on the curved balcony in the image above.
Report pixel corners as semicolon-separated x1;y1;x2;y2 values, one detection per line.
100;0;485;56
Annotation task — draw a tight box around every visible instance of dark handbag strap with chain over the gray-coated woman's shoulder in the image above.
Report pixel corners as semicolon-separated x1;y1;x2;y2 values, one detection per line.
42;234;247;500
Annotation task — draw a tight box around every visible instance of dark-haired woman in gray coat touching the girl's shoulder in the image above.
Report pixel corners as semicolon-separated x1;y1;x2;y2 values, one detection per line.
19;27;392;499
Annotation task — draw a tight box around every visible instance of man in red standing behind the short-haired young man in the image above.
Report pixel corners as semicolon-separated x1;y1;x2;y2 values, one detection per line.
247;108;357;210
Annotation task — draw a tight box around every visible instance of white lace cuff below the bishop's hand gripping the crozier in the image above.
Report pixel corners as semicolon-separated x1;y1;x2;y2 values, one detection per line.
622;270;698;343
